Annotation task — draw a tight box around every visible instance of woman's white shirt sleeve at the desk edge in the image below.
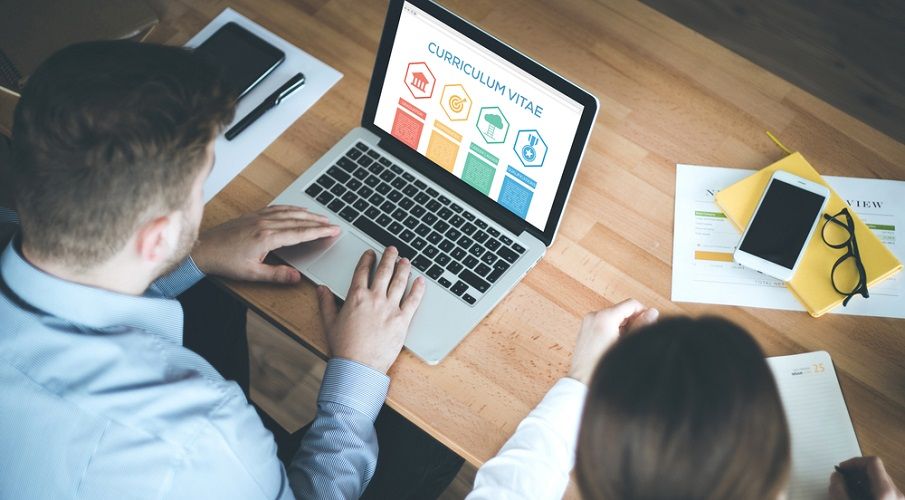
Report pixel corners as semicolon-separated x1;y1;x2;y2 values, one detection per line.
467;378;587;500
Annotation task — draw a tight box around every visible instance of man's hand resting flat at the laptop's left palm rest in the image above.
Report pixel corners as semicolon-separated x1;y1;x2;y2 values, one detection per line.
192;205;339;283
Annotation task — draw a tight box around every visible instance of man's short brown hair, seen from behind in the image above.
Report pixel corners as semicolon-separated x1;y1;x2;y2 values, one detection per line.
12;41;235;269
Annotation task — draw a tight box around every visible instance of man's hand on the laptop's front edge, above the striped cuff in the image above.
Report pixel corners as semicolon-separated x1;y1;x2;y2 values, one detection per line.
317;247;424;373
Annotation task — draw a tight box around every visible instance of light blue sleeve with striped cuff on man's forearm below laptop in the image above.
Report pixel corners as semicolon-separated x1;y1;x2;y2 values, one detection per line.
288;358;390;499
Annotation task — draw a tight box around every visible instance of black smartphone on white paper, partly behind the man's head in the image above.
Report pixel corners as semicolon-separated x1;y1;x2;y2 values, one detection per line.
195;23;286;100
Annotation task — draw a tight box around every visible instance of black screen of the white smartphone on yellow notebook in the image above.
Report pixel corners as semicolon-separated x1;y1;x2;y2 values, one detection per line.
739;179;823;269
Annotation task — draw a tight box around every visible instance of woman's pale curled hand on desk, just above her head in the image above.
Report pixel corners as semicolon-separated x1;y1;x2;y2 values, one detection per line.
569;299;660;384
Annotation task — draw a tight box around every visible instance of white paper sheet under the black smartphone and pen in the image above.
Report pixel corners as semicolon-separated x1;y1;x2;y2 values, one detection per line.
185;8;343;202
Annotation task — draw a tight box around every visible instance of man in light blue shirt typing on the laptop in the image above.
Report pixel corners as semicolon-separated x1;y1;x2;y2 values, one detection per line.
0;42;424;498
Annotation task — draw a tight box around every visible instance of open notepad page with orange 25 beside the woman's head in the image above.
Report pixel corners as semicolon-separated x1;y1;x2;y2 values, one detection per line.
767;351;861;500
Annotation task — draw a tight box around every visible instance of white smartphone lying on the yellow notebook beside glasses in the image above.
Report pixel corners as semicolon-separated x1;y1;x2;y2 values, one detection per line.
733;170;830;281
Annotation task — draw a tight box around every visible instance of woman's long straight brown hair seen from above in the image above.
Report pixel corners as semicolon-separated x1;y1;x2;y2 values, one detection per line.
576;317;790;500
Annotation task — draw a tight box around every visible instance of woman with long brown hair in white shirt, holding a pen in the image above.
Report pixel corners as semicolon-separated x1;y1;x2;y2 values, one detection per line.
468;300;905;500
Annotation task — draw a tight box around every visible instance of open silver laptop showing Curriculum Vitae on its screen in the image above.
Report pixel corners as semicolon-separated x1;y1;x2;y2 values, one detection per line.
273;0;598;364
